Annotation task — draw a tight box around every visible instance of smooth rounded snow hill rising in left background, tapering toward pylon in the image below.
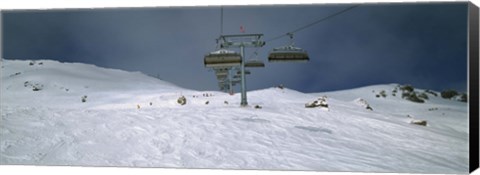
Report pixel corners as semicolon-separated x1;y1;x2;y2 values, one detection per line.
1;60;189;108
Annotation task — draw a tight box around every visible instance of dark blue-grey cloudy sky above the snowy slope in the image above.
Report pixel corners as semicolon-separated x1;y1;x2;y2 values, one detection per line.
2;2;467;92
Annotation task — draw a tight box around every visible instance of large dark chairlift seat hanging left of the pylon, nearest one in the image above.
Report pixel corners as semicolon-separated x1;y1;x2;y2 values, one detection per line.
204;49;242;68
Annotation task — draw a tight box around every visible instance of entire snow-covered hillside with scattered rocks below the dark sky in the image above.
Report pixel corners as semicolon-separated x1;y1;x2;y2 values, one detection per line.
0;60;469;173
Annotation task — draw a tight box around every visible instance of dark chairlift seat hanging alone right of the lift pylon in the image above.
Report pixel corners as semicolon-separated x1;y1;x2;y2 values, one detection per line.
268;46;310;62
